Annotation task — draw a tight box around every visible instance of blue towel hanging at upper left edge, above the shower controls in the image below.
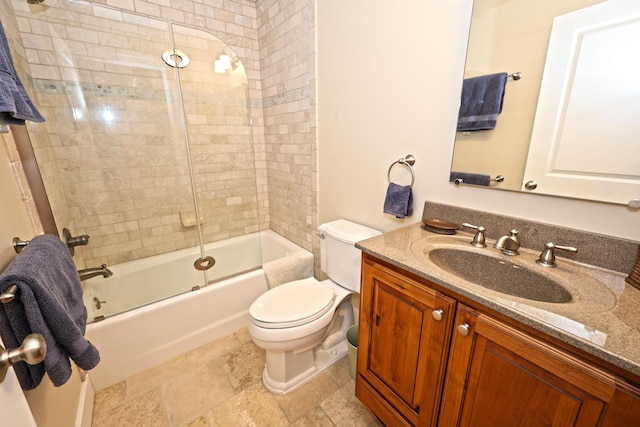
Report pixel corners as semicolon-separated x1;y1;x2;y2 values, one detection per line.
0;21;44;125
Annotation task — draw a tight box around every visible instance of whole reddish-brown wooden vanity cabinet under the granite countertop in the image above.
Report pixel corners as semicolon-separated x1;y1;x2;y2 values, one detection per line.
356;254;640;427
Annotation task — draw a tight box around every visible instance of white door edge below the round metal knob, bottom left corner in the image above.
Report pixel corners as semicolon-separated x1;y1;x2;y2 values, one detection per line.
0;341;36;427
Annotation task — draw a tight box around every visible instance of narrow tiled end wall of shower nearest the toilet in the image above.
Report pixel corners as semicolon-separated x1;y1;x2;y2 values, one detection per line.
257;0;318;254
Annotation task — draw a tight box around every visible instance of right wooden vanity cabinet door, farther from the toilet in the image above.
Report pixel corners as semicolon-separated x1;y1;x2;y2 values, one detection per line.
440;305;615;427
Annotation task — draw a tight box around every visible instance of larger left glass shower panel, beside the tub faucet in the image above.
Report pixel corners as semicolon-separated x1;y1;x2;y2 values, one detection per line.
24;2;206;319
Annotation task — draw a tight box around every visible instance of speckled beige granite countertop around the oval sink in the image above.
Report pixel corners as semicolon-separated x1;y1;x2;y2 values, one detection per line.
356;223;640;375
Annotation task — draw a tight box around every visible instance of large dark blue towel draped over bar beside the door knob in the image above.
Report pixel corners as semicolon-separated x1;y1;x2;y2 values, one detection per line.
0;234;100;390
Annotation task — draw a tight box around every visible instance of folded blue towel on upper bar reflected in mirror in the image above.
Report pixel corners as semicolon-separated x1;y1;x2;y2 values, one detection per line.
458;73;507;132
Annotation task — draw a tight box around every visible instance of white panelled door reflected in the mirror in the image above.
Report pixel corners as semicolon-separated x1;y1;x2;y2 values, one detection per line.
523;0;640;204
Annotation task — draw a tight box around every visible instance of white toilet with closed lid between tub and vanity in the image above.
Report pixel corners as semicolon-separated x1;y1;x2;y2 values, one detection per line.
249;219;380;394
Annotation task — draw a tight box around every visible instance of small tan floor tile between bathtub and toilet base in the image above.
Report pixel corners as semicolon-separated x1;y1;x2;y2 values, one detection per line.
222;342;265;390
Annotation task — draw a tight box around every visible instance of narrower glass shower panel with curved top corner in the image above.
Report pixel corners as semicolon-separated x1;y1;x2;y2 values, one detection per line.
172;25;262;283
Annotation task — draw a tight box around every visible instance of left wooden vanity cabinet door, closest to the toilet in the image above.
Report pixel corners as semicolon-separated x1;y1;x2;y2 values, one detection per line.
356;262;455;425
